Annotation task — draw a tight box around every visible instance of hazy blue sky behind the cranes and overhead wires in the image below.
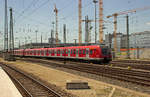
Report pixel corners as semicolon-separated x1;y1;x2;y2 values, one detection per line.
0;0;150;48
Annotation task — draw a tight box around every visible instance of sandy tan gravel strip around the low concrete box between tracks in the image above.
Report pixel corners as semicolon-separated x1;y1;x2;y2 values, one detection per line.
0;58;150;97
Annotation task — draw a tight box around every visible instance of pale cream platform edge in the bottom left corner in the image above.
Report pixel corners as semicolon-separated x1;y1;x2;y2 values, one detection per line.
0;67;22;97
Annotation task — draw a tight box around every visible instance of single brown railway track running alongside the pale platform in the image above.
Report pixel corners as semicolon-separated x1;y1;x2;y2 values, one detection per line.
1;64;62;97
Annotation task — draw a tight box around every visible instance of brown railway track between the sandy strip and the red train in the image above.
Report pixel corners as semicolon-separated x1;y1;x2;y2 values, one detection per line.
19;59;150;86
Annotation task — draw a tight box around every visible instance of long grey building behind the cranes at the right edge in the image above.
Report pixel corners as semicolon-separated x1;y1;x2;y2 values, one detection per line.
105;31;150;51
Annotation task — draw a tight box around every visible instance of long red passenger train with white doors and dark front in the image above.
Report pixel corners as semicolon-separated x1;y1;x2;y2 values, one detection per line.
14;45;112;62
